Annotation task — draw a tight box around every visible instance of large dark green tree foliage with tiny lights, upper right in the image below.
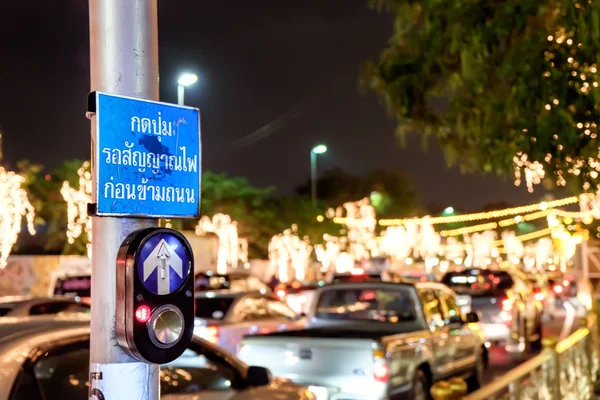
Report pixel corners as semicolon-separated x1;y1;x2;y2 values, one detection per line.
362;0;600;189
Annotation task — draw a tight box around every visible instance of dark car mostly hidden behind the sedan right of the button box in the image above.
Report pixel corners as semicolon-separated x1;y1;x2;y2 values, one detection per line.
194;271;272;293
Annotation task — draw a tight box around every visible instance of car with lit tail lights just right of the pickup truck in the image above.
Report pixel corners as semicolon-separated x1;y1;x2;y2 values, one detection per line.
442;268;543;353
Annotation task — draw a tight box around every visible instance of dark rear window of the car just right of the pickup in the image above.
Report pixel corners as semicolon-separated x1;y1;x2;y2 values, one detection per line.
442;269;514;296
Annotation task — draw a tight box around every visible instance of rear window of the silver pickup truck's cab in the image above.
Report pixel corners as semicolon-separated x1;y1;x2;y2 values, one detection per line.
316;286;416;323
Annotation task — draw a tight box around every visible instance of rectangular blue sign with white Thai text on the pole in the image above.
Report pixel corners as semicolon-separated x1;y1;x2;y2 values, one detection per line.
94;92;201;218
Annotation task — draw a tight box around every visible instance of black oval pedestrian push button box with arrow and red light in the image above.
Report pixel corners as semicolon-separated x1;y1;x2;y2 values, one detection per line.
116;228;195;364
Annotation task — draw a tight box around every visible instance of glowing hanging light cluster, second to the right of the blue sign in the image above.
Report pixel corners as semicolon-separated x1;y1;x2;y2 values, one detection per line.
269;225;313;283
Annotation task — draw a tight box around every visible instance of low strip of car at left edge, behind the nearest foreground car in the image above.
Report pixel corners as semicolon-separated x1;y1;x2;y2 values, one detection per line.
0;296;90;317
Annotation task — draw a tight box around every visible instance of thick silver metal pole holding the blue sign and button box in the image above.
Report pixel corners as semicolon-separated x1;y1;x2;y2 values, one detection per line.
89;0;159;400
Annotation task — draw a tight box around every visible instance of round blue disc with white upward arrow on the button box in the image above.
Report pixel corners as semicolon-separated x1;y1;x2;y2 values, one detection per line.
135;233;191;295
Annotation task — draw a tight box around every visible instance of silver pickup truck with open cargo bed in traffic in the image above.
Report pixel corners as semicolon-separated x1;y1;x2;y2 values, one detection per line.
238;282;488;400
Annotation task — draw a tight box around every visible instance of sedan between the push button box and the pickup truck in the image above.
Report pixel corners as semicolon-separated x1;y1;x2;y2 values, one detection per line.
194;290;304;354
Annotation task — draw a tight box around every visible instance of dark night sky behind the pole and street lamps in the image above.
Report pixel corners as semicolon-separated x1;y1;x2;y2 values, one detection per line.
0;0;564;211
